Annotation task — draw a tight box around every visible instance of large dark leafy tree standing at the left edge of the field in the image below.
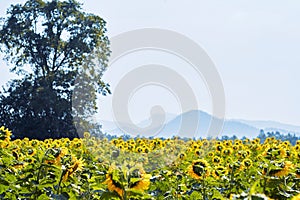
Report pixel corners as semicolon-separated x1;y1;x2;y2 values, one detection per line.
0;0;110;138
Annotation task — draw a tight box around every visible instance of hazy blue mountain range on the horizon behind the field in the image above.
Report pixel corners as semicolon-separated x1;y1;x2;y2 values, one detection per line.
99;110;300;138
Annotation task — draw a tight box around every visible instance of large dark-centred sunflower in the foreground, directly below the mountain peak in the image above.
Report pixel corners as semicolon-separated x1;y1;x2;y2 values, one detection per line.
188;159;210;179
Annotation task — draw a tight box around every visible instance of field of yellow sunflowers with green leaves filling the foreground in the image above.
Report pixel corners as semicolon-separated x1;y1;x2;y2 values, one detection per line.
0;126;300;200
